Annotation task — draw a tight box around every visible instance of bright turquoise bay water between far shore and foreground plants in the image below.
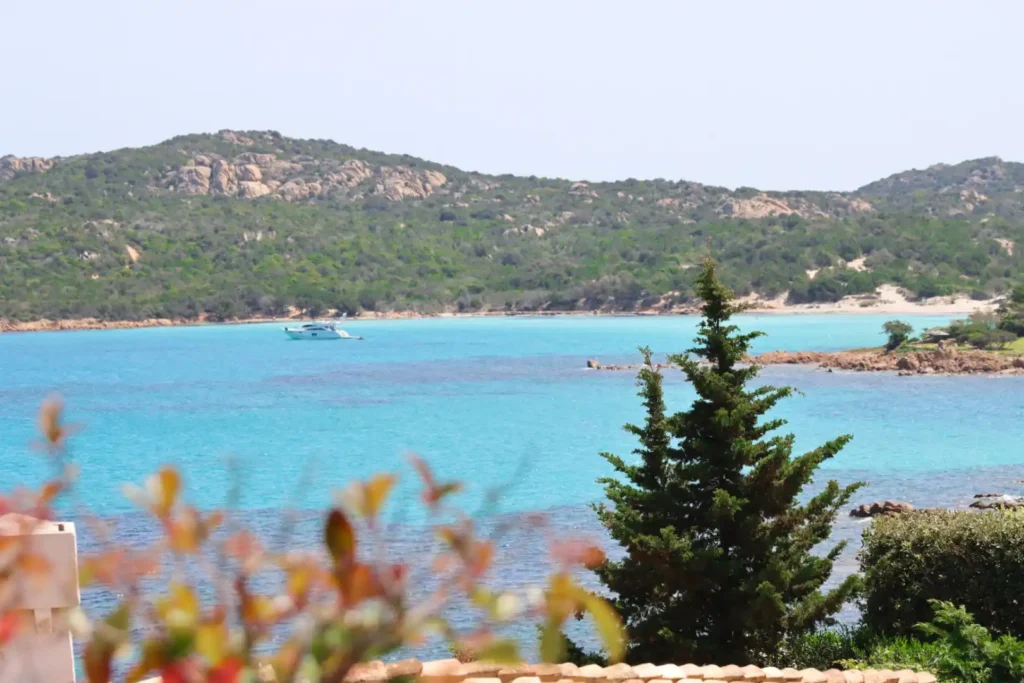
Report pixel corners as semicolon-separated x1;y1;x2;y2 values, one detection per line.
0;314;1024;654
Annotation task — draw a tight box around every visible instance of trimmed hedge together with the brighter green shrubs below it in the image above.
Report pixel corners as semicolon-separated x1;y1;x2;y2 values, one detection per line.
773;510;1024;683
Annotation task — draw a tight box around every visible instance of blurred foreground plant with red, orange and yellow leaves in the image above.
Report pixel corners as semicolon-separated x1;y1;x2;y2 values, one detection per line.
0;399;624;683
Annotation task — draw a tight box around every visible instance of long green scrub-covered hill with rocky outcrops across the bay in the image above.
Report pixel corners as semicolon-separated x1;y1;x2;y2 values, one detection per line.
0;130;1024;321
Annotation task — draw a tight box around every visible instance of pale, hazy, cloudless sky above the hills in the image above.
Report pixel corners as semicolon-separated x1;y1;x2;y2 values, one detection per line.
0;0;1024;190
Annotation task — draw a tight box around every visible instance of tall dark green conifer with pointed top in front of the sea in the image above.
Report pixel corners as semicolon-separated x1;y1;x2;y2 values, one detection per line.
595;258;860;665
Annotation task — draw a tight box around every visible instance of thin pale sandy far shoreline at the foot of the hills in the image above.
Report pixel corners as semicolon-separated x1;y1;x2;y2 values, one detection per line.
0;287;998;334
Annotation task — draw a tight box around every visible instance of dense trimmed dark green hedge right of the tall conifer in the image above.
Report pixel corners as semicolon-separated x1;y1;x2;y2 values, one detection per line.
860;510;1024;636
